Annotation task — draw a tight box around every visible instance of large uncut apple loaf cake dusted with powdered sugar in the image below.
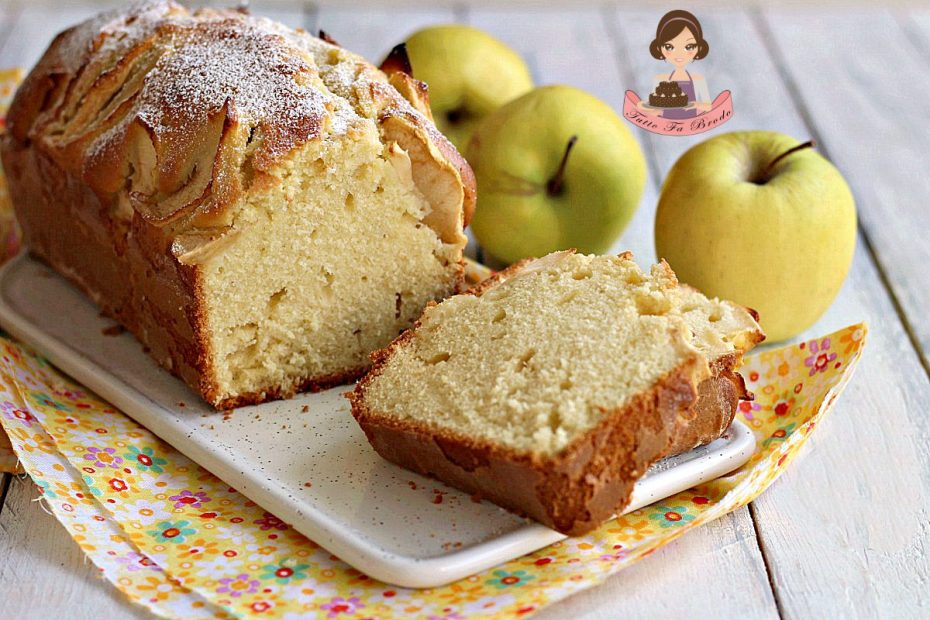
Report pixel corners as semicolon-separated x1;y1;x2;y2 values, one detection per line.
2;1;475;408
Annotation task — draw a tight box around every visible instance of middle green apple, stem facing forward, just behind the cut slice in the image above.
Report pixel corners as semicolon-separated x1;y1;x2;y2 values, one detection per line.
466;86;646;262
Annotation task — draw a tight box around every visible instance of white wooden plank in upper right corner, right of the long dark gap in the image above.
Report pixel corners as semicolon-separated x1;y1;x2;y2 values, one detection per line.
762;9;930;372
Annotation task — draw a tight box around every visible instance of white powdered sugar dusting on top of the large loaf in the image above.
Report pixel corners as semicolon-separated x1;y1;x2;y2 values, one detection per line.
62;0;357;168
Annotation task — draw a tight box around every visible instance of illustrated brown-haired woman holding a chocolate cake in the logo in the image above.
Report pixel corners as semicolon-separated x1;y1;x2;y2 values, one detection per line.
639;10;711;119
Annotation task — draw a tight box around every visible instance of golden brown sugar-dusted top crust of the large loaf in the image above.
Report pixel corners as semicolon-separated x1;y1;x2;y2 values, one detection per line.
7;0;475;246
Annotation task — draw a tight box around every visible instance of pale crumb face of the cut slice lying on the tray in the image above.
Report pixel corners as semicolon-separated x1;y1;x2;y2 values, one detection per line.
358;253;757;456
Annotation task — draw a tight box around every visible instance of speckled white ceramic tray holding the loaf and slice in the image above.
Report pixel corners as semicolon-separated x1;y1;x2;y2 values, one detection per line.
0;255;755;588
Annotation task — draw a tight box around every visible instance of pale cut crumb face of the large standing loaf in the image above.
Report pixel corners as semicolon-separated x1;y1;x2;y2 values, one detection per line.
202;119;461;400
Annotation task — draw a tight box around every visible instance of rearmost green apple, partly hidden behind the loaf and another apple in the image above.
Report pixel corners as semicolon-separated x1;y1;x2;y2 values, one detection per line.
396;25;533;151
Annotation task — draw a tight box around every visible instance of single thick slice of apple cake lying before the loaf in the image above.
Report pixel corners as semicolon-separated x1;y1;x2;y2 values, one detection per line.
348;251;764;535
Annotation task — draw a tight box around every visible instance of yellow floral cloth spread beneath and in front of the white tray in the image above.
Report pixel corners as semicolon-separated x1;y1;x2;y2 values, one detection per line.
0;324;866;620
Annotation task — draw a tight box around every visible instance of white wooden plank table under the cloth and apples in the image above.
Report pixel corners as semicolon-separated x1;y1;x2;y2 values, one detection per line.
0;0;930;620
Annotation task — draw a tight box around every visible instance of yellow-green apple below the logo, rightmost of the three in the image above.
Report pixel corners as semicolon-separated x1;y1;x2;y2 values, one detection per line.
655;131;856;341
